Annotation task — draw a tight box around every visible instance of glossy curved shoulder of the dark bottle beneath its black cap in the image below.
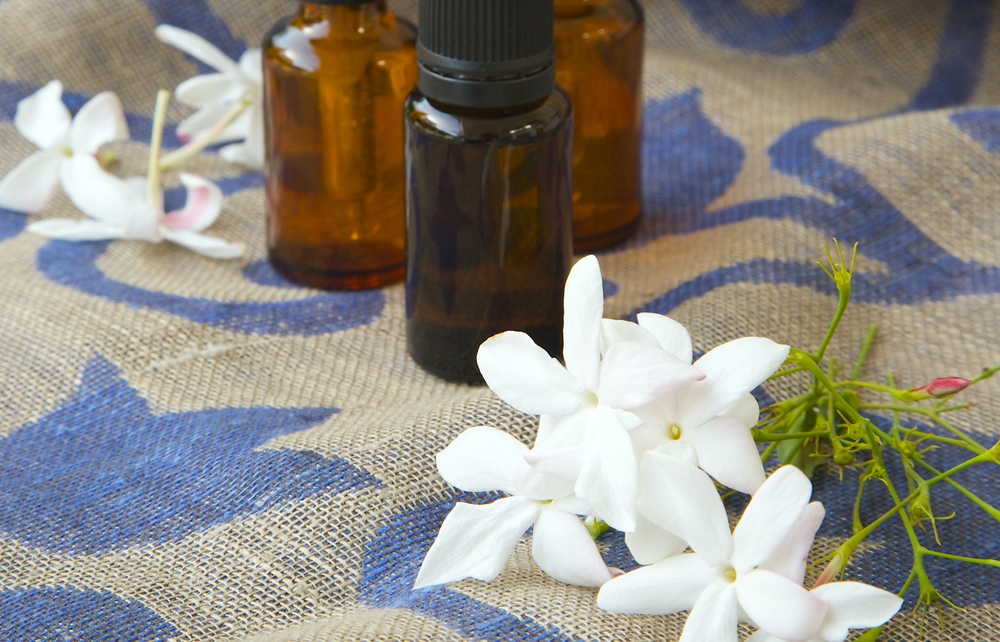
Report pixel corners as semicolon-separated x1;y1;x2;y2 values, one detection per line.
404;87;573;145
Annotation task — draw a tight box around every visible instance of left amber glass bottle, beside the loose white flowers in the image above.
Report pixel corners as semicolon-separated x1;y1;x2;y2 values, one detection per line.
263;0;417;290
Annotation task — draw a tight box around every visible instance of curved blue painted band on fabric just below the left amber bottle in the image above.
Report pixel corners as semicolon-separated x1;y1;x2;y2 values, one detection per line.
38;241;385;337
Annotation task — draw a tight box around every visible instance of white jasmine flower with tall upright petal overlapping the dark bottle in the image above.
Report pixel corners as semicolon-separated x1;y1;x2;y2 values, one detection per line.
478;256;704;532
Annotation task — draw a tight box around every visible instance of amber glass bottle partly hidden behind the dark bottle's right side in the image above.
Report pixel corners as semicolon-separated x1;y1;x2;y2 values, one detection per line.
555;0;643;253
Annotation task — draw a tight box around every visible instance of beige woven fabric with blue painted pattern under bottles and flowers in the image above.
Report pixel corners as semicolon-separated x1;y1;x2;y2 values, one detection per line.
0;0;1000;642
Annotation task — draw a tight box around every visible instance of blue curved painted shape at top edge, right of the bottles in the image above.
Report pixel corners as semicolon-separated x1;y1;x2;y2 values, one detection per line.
680;0;857;56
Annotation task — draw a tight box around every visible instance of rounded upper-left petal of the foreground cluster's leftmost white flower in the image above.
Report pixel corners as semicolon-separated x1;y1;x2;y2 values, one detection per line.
437;426;528;495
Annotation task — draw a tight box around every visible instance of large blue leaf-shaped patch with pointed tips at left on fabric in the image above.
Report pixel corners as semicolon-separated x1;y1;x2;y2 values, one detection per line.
0;357;379;555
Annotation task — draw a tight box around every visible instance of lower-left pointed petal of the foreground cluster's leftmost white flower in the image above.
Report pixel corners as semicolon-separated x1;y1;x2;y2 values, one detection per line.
413;497;539;588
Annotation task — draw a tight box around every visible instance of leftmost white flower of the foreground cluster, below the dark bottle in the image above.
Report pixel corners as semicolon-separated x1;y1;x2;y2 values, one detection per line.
414;427;611;588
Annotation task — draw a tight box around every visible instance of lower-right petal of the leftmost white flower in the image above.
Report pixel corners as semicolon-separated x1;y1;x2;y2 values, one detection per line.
59;154;145;226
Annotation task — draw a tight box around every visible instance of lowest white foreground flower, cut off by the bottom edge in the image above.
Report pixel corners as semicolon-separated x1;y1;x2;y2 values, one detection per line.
597;460;829;642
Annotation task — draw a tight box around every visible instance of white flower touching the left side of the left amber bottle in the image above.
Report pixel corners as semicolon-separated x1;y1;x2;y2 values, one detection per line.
156;25;264;169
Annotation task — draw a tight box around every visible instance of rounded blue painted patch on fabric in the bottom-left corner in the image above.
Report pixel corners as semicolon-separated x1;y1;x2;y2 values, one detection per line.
0;586;180;642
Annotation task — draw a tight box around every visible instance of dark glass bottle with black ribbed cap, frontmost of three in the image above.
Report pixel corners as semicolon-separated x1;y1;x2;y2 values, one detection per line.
405;0;573;384
